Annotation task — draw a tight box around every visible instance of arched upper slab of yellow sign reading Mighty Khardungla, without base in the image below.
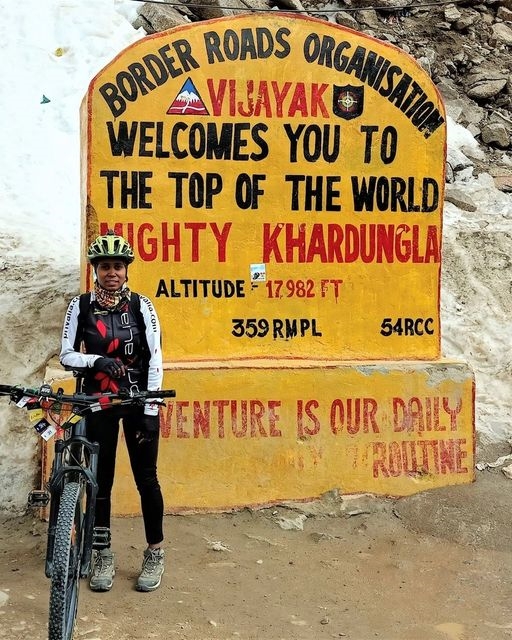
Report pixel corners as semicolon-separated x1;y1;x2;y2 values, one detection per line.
82;14;446;361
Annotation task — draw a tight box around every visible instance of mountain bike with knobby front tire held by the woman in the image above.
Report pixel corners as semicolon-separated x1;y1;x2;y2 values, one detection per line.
0;384;176;640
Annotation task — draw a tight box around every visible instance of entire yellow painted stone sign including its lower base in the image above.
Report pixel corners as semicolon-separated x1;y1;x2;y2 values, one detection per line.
74;13;474;514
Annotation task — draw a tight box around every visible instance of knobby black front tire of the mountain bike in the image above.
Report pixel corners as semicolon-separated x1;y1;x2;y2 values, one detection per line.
48;482;83;640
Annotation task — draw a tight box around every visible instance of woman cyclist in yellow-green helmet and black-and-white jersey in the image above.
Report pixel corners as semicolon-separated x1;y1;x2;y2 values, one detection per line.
60;231;164;591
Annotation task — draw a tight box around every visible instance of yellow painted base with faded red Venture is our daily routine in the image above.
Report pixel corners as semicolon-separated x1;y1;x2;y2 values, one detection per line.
43;360;475;515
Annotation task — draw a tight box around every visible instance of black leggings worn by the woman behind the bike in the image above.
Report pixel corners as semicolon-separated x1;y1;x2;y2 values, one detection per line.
87;409;164;544
